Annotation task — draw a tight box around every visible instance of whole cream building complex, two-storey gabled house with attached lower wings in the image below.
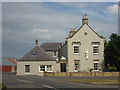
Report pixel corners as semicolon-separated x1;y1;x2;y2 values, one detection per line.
17;14;105;75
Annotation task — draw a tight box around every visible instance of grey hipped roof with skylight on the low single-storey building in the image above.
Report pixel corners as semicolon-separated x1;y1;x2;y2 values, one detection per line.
19;46;54;61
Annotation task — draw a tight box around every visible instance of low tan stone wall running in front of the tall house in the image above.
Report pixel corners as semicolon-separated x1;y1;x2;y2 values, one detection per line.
44;72;120;76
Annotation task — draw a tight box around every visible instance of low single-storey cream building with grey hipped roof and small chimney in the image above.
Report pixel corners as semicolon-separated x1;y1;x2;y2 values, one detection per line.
17;40;59;76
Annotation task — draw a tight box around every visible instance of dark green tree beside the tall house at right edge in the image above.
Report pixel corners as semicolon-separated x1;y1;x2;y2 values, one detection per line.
104;33;120;71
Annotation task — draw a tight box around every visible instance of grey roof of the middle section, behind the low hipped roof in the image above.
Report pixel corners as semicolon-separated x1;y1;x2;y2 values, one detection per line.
40;42;63;51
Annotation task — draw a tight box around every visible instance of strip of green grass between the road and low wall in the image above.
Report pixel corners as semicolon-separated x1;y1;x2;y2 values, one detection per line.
64;79;118;84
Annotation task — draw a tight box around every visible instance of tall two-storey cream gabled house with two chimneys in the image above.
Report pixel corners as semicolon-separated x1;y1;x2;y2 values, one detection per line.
60;15;105;72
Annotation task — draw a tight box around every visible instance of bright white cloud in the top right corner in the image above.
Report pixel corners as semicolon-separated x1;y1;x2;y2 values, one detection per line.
106;4;118;15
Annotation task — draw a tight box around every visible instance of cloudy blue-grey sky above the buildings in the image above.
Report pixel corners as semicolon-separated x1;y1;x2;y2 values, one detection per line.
0;2;118;58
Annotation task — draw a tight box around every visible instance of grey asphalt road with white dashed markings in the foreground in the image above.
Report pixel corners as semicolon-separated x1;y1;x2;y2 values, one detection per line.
2;75;118;90
